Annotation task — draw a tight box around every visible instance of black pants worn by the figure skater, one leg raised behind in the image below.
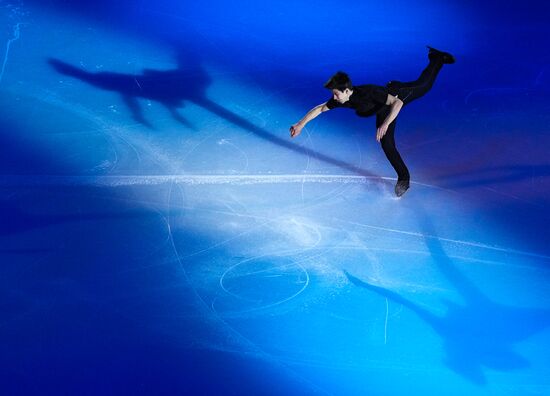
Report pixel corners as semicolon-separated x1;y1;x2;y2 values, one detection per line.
376;60;443;180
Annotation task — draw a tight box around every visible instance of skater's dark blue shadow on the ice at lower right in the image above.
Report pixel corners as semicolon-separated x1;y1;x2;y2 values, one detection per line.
345;206;550;385
